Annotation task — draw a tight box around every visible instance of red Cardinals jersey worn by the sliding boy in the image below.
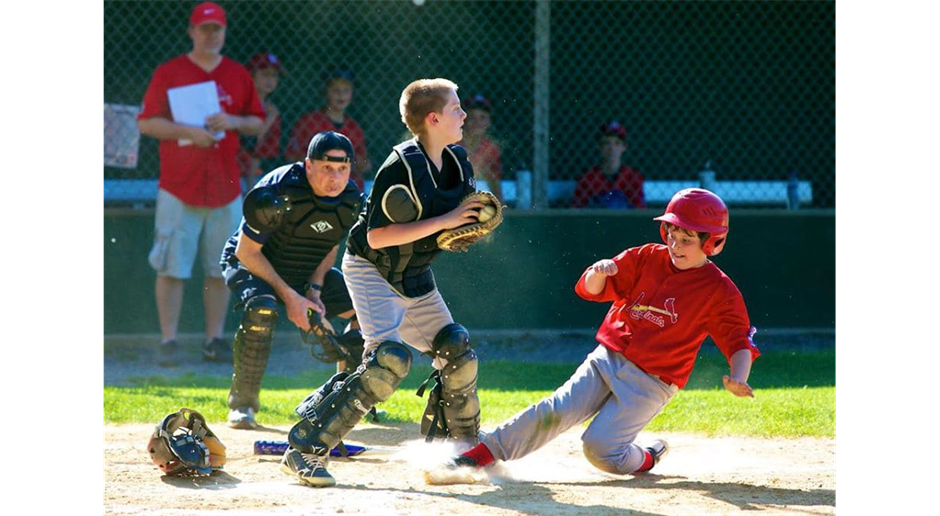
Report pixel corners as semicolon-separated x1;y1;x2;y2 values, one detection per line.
575;244;760;388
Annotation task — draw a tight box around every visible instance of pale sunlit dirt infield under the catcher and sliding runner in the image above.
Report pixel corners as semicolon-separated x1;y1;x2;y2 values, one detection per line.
103;423;836;515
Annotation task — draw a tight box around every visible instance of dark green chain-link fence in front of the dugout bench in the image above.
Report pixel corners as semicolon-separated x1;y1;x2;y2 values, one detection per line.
103;0;836;208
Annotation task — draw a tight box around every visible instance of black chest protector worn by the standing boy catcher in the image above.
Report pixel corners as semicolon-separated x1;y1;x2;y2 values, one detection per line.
367;139;476;297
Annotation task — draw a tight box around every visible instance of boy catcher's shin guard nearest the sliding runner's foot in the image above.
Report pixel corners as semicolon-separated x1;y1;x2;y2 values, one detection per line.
421;323;480;444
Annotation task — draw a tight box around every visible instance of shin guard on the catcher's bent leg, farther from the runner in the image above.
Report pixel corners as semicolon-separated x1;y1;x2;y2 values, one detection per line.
287;341;411;455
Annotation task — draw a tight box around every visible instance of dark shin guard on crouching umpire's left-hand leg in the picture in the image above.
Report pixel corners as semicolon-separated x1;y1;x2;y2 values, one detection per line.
228;296;277;412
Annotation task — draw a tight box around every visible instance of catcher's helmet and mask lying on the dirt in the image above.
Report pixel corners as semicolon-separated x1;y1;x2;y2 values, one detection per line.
147;408;225;475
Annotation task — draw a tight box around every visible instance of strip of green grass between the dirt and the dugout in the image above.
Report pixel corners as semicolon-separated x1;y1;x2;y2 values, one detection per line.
103;349;836;437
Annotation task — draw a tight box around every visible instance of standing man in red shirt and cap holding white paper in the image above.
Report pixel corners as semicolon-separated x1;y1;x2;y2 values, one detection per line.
137;2;264;366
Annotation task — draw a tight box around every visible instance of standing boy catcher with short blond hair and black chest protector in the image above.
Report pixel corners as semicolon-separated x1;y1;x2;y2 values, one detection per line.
282;79;499;487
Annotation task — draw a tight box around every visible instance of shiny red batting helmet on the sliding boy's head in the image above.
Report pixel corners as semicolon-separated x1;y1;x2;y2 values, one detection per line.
653;188;728;256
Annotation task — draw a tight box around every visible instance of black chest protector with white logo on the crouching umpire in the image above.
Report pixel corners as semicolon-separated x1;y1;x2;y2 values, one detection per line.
261;163;360;286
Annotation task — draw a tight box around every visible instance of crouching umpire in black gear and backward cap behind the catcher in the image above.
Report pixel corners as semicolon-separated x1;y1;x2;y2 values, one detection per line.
221;132;362;429
